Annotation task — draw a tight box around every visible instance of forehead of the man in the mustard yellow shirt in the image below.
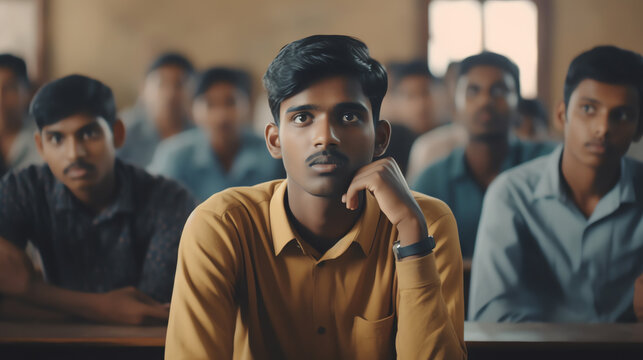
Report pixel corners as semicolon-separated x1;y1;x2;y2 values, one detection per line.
279;76;372;113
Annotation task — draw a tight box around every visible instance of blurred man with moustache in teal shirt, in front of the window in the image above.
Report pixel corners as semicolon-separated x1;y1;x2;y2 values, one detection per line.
413;52;553;259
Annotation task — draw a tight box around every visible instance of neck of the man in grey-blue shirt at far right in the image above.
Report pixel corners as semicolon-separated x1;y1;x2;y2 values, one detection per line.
560;148;621;217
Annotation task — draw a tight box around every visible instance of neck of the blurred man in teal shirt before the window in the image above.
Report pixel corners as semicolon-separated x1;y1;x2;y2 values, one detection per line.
465;136;509;189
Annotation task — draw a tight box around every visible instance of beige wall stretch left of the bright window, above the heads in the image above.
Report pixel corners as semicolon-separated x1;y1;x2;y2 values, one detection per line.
48;0;421;107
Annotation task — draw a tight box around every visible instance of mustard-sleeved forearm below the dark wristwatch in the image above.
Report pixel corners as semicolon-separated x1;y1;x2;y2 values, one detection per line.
396;254;466;359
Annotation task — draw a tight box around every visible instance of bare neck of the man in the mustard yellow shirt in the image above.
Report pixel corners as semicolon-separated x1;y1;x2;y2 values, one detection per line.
285;182;364;254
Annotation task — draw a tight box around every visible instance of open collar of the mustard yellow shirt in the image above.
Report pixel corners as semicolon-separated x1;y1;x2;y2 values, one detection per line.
270;180;381;260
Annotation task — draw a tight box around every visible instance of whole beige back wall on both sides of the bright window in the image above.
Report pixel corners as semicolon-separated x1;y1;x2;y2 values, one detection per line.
46;0;643;115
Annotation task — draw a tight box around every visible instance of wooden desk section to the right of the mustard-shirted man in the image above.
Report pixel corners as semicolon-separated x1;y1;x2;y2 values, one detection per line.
464;322;643;360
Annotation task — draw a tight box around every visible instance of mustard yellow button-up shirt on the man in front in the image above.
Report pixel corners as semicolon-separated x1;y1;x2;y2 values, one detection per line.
165;180;466;360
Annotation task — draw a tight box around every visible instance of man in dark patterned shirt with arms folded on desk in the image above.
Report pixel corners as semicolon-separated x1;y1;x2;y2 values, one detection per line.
0;75;195;324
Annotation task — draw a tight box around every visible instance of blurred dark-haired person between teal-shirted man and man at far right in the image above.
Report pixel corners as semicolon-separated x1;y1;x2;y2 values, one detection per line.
513;99;549;141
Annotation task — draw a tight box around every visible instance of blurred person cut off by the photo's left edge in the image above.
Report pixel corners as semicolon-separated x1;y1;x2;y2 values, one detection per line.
0;54;42;176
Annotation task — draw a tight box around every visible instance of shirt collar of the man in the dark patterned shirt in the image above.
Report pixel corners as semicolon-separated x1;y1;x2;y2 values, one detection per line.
54;159;134;219
